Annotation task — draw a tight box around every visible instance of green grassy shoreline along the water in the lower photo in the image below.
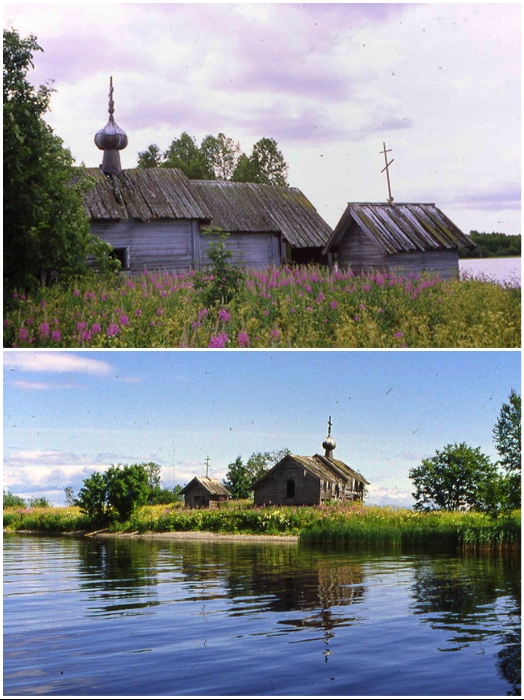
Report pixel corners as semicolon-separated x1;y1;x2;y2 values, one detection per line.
4;502;521;551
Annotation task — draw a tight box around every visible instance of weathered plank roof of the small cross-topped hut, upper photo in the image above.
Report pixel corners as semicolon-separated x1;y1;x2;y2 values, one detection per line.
324;203;475;255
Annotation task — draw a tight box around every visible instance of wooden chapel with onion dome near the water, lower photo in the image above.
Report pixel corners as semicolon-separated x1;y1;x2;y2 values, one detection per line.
254;418;369;506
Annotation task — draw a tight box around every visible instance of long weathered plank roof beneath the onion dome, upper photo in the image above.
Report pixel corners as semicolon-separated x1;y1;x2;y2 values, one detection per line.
78;168;332;248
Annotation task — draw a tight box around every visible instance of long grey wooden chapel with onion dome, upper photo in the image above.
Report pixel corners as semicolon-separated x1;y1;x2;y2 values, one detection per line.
83;78;332;273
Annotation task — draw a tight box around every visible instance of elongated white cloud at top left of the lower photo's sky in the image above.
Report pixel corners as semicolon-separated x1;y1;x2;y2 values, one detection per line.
3;350;113;376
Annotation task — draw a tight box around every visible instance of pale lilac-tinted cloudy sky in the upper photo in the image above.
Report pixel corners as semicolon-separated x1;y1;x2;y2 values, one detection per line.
3;2;521;234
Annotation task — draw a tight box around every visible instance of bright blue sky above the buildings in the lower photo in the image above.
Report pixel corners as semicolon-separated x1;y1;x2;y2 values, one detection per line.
3;350;521;506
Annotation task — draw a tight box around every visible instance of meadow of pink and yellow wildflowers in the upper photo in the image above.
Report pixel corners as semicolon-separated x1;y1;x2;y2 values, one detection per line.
4;266;521;349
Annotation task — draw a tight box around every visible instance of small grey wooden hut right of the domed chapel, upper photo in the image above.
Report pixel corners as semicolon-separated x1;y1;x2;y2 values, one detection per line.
323;203;475;278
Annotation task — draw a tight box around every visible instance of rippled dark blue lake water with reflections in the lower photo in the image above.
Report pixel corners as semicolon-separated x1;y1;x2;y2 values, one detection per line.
4;534;520;697
